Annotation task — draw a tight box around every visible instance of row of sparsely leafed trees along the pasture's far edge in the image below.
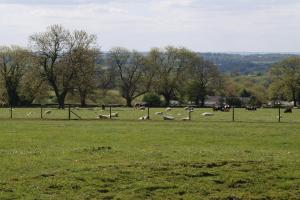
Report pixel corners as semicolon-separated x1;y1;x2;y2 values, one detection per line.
0;25;300;108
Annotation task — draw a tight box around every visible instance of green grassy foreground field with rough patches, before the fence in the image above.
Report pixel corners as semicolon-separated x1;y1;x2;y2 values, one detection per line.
0;109;300;199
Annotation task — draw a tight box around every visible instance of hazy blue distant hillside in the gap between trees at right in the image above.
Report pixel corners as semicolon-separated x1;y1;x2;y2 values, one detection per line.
200;53;295;74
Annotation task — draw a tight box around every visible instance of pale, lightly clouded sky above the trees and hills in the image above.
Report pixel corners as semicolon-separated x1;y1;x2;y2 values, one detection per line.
0;0;300;52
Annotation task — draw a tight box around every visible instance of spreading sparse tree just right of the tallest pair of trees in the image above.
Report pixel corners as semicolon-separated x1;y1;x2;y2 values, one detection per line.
109;48;154;107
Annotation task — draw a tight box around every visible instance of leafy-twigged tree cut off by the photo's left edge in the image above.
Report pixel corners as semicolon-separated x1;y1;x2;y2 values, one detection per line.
0;46;31;106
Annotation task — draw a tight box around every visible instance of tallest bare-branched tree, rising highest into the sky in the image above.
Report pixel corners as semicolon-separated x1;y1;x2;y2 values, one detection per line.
30;25;75;108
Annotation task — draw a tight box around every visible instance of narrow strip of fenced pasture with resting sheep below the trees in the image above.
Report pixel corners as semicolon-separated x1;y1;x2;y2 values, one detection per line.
0;104;300;123
